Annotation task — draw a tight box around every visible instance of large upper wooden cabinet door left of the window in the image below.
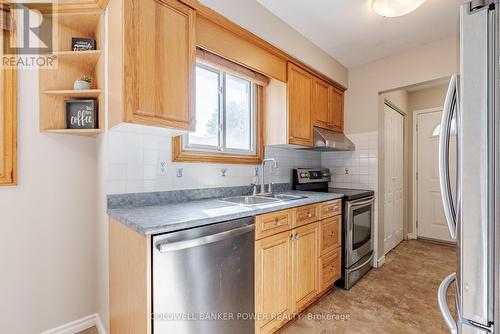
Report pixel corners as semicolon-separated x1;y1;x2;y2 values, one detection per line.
123;0;196;130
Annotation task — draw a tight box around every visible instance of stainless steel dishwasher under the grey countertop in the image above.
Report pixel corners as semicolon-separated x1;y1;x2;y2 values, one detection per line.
152;218;255;334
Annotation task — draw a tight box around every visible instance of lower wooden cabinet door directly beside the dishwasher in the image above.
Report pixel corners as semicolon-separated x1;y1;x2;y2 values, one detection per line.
255;231;291;333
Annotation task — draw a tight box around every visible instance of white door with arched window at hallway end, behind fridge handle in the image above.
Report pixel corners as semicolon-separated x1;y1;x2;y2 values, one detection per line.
417;110;456;241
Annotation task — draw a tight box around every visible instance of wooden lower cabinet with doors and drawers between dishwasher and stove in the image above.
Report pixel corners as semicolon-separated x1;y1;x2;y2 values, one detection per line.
255;204;342;333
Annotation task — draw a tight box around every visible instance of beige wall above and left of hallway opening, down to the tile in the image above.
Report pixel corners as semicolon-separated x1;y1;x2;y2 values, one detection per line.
345;37;459;133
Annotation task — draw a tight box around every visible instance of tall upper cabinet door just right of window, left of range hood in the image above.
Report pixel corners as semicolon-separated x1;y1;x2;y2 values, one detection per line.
287;63;313;147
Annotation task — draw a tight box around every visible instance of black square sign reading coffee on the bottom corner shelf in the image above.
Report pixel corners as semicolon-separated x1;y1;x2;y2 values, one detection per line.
64;99;97;129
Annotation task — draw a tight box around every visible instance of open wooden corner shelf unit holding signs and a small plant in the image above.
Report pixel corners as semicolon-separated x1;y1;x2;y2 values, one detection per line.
39;9;105;136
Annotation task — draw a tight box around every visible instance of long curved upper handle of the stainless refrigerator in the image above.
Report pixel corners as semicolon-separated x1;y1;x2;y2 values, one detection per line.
439;75;458;239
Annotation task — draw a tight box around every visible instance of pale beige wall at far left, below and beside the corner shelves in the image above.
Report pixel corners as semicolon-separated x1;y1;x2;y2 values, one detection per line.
0;70;97;334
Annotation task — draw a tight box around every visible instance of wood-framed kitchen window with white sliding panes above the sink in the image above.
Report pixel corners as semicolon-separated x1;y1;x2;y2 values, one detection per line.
173;51;267;164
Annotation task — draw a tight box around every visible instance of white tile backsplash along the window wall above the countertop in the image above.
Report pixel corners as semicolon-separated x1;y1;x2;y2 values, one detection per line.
107;129;321;194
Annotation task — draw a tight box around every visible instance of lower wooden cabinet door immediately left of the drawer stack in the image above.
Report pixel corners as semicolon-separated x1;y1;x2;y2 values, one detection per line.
292;222;319;312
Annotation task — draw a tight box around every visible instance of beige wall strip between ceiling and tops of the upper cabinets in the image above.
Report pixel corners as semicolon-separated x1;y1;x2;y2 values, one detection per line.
200;0;348;87
